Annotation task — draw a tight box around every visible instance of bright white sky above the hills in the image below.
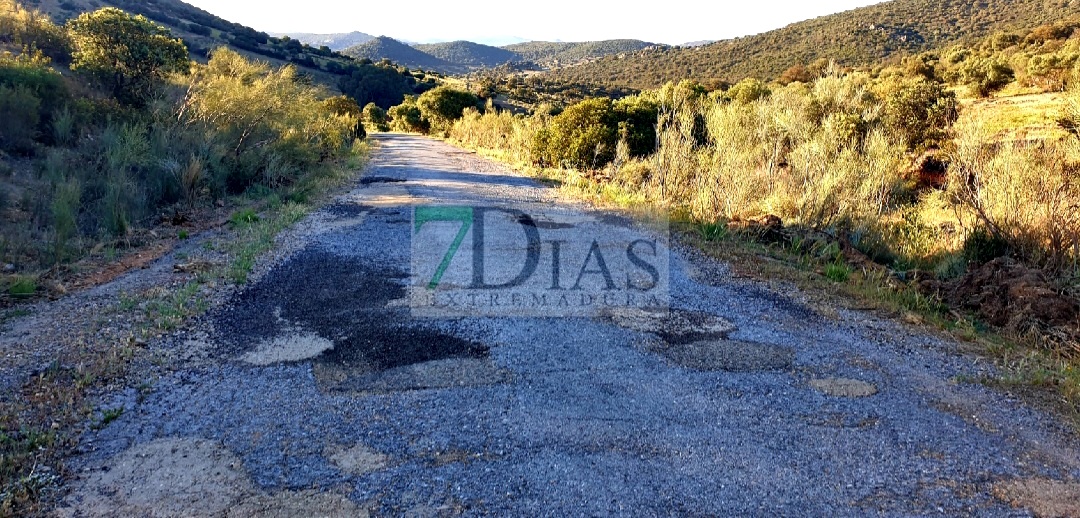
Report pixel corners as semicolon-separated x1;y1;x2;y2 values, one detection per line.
185;0;880;45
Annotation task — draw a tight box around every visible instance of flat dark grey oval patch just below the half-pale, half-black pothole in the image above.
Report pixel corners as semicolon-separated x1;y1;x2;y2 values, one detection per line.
650;340;795;372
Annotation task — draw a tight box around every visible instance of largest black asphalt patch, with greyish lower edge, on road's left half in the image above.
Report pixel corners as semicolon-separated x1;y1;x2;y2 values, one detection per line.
213;249;501;391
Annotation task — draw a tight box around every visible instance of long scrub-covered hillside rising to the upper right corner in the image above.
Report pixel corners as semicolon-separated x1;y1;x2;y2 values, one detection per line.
544;0;1080;88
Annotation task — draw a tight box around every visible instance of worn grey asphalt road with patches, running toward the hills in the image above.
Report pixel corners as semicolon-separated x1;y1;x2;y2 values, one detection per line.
65;135;1080;516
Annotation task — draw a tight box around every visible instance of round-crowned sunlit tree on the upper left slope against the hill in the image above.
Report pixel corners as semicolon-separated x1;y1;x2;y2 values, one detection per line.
68;8;190;106
